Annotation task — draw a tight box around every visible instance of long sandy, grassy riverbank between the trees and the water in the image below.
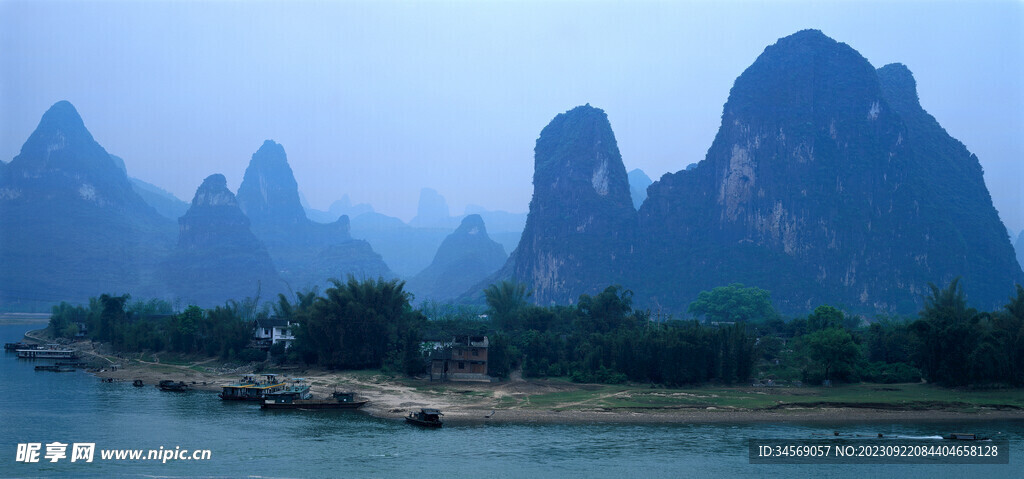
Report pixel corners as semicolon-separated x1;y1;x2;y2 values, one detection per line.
14;335;1024;425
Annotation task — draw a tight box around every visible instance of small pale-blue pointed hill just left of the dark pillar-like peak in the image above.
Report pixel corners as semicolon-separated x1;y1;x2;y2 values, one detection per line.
407;215;508;301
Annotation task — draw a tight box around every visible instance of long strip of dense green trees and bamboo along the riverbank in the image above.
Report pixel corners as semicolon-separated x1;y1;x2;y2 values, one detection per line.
50;277;1024;386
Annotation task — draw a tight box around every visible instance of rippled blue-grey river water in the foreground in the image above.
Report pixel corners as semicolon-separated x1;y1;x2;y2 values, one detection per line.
0;324;1024;479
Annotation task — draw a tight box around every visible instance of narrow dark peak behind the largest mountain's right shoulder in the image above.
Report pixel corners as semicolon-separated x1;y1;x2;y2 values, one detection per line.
878;63;1024;308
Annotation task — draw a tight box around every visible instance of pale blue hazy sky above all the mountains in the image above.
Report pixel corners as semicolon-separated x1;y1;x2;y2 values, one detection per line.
0;0;1024;231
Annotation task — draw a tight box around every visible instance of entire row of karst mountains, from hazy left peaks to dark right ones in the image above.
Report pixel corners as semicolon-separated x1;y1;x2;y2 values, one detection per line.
0;30;1024;314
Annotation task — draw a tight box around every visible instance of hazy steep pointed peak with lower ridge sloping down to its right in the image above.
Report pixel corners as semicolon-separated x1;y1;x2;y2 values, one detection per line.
238;140;392;291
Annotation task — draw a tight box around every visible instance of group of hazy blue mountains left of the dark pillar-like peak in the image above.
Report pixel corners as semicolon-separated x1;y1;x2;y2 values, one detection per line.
0;101;516;310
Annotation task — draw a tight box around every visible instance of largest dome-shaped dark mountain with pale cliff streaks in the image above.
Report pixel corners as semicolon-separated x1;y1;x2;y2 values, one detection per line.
633;31;1021;312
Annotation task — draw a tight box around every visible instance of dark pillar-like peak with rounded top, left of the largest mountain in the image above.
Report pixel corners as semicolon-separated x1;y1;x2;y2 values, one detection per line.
499;104;636;303
